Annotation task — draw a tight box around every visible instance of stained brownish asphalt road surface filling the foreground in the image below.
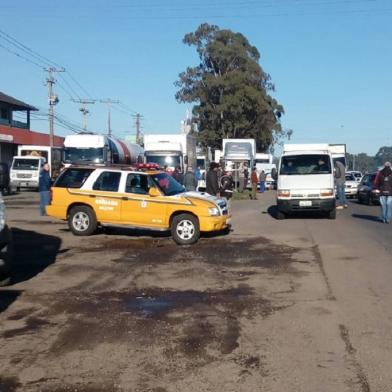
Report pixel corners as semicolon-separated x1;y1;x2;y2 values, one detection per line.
0;192;392;392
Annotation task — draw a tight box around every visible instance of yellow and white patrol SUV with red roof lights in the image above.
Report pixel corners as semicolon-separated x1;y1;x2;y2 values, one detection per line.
46;166;230;245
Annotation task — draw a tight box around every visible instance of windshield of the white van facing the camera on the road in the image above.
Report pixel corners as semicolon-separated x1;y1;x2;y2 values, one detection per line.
280;154;332;175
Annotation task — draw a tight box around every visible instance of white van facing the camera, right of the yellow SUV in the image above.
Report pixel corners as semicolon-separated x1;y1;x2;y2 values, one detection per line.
277;144;336;219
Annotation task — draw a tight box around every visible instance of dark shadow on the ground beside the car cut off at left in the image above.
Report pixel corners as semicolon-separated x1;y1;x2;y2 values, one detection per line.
11;228;61;284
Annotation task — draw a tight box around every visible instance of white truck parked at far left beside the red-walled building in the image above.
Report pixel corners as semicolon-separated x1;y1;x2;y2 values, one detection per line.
10;145;63;190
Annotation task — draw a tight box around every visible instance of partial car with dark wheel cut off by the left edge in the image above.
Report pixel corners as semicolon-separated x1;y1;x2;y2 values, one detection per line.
0;196;12;286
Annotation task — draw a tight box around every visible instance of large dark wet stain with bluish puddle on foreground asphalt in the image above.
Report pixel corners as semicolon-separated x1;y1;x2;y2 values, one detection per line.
48;286;284;359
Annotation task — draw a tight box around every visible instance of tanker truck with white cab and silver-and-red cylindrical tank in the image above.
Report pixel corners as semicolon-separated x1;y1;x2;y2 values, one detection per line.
63;133;144;166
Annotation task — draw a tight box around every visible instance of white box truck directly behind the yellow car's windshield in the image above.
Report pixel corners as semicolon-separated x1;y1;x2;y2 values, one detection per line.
144;134;197;173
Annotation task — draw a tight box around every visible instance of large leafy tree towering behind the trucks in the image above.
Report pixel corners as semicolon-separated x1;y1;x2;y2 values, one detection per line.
175;24;284;150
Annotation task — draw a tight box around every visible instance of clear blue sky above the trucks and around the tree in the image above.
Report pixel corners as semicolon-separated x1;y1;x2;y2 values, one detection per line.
0;0;392;154
